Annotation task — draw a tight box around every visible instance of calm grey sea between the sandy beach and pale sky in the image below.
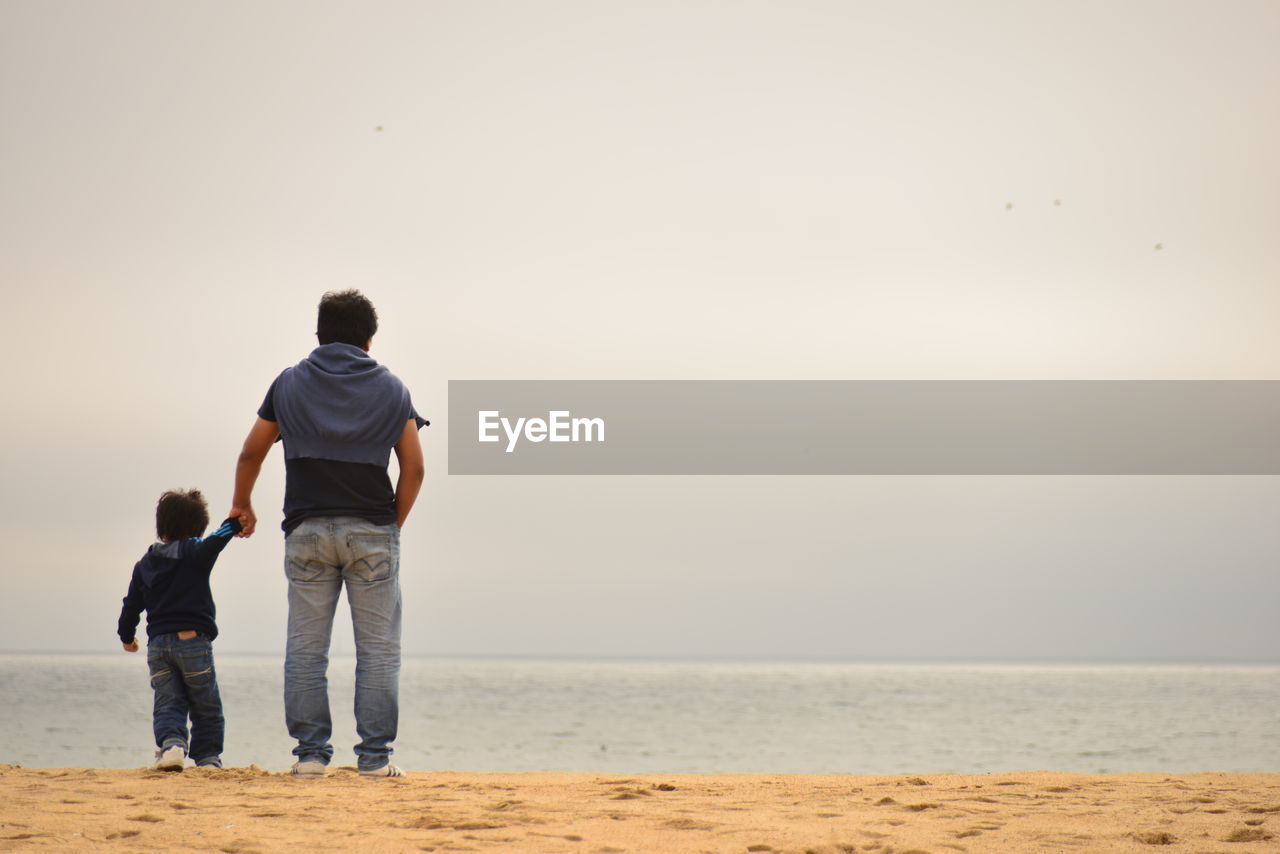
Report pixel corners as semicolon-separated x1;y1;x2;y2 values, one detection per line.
0;654;1280;775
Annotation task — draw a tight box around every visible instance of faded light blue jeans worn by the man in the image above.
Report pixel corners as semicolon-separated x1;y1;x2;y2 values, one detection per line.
284;516;401;771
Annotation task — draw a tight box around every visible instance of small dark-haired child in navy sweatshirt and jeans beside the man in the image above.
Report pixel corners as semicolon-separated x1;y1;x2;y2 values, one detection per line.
118;489;241;771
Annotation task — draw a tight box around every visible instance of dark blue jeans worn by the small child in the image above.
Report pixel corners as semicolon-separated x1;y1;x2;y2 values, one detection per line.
147;632;224;764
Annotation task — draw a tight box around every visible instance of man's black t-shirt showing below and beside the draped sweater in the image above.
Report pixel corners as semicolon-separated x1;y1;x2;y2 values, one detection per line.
257;383;396;534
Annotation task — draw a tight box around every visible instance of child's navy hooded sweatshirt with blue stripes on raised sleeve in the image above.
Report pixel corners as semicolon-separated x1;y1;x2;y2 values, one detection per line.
118;519;241;643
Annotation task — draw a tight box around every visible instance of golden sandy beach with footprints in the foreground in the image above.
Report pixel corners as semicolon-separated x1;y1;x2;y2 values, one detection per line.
0;766;1280;854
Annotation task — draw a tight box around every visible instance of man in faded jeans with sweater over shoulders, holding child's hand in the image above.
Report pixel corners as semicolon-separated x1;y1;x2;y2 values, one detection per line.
228;291;426;777
